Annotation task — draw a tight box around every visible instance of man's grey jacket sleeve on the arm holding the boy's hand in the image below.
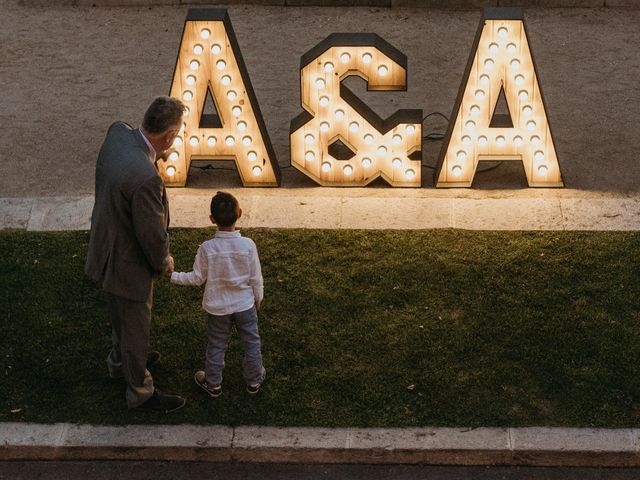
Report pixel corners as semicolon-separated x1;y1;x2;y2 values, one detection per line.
131;176;169;273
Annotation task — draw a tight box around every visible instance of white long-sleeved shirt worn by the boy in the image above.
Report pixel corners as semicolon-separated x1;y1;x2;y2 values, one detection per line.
171;230;264;315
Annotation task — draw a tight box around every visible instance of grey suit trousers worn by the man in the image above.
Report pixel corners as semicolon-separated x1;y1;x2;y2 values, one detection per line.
107;293;154;408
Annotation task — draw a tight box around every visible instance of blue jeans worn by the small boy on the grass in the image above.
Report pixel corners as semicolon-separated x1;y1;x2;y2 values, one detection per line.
205;306;262;386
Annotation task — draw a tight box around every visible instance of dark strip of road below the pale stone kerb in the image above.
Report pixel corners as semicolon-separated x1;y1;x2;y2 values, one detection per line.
0;462;640;480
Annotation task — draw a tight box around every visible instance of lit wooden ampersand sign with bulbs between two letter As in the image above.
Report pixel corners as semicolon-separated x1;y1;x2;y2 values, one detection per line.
290;34;422;187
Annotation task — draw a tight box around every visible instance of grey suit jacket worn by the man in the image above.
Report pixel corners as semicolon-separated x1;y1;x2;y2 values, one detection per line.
85;122;169;302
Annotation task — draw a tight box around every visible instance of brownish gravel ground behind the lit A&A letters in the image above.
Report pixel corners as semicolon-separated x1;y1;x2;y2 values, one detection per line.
0;0;640;197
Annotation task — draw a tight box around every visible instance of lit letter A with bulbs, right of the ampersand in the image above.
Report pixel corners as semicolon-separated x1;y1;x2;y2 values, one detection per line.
434;8;564;187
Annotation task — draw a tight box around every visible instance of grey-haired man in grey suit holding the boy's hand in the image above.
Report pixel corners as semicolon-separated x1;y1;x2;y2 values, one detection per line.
85;97;185;413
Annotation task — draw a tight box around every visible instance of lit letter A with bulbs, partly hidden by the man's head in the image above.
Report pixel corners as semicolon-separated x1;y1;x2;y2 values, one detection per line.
161;9;280;186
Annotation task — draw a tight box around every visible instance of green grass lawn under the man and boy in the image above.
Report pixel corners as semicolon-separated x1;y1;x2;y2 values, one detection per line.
0;229;640;427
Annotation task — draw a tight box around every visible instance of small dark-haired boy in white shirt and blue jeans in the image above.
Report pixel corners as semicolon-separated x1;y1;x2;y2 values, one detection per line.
171;192;266;398
